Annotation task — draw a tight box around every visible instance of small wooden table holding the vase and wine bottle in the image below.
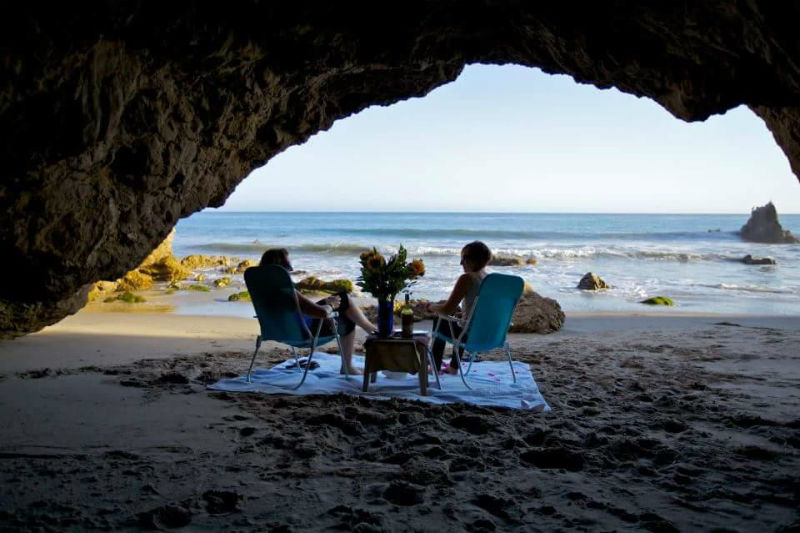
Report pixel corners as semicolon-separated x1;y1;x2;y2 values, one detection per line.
363;331;439;396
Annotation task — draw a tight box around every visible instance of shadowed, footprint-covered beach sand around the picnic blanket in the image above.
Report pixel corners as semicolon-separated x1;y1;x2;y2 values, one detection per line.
0;311;800;532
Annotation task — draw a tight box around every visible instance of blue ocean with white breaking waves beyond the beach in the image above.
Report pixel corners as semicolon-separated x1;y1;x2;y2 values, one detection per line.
173;211;800;316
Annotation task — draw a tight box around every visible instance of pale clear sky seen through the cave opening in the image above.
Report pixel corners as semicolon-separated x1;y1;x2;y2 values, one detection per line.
220;65;800;214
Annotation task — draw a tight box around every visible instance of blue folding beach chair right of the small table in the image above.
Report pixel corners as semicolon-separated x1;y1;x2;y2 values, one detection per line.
431;274;525;389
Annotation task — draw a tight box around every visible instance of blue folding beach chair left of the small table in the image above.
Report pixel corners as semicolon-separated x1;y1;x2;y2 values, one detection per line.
244;265;347;390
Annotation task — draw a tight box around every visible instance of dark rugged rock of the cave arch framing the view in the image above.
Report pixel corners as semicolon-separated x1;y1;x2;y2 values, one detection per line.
0;0;800;337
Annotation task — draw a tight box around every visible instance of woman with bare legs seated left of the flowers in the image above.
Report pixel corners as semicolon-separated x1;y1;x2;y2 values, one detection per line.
259;248;378;374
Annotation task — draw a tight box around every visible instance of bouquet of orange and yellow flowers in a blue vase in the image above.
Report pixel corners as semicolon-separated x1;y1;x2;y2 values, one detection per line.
356;244;425;337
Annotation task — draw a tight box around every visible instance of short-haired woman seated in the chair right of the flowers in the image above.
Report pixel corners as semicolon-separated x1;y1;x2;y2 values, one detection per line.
428;241;492;374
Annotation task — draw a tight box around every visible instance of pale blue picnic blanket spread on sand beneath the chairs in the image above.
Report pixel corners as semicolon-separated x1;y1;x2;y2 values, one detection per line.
208;352;550;411
